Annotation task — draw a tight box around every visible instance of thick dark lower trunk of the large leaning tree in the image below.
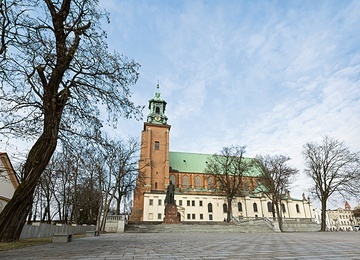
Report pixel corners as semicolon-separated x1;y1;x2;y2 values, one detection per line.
0;98;66;242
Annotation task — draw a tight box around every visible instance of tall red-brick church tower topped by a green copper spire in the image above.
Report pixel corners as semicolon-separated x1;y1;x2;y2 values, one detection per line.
130;85;171;222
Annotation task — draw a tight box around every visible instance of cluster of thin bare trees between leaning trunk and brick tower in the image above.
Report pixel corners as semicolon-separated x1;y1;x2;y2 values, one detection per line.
27;138;140;230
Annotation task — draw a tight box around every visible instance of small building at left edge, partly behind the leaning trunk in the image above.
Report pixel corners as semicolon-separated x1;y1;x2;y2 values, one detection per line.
0;152;19;212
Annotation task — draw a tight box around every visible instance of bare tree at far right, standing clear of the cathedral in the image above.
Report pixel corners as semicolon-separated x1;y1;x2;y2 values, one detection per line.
303;136;360;231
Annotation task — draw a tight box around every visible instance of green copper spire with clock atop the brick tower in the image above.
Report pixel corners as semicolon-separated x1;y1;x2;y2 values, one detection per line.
147;83;168;125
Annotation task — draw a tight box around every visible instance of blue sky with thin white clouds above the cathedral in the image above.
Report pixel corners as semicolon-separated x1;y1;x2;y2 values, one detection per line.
1;0;360;207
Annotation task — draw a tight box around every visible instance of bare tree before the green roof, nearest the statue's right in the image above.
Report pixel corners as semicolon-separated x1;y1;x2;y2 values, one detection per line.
206;146;249;221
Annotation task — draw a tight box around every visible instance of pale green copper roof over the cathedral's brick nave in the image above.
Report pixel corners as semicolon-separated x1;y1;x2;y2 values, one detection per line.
169;152;261;177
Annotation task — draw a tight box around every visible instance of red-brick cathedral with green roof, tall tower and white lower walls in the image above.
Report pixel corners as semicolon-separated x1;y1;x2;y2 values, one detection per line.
130;86;313;223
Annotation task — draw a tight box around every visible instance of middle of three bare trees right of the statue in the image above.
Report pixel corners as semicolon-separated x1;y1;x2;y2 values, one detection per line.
255;155;299;231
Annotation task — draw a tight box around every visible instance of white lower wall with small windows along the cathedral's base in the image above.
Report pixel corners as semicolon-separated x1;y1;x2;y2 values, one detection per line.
143;193;313;222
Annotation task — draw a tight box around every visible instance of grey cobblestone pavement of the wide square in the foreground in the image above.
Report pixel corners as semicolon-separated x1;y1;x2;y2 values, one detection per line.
0;232;360;259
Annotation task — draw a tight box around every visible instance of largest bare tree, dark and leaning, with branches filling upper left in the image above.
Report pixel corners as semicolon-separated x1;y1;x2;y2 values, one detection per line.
0;0;142;241
